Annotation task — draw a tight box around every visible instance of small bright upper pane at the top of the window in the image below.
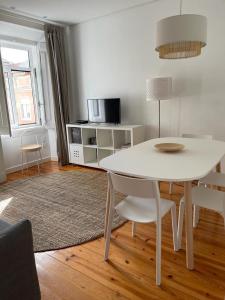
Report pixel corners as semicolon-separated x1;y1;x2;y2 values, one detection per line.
1;47;30;69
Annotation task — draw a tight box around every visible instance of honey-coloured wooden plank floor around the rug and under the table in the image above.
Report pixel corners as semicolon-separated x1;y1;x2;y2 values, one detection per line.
5;162;225;300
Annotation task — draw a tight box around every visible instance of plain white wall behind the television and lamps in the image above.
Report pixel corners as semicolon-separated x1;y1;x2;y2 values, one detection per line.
72;0;225;154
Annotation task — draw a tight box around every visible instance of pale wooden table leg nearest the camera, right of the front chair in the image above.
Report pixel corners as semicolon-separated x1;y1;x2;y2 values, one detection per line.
184;181;194;270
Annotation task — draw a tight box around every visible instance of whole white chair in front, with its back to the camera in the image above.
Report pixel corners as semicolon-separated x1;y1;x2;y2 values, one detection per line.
105;172;177;285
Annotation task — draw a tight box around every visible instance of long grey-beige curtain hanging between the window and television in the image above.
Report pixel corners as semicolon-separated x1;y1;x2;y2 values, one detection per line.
45;24;69;165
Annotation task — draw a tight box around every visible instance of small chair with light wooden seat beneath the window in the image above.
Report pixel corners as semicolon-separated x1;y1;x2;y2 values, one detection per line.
20;130;43;175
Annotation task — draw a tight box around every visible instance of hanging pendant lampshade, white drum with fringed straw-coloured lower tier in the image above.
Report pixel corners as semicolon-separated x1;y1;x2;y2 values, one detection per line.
155;14;207;59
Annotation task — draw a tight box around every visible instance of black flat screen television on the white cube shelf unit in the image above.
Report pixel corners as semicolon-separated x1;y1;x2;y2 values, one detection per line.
87;98;120;124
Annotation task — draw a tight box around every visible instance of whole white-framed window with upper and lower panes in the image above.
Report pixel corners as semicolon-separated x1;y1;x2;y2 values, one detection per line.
0;42;41;128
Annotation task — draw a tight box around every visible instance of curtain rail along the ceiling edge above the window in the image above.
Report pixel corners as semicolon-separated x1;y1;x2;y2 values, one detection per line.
0;6;69;30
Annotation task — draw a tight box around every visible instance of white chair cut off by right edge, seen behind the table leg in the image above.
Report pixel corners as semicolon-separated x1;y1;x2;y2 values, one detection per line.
177;186;225;249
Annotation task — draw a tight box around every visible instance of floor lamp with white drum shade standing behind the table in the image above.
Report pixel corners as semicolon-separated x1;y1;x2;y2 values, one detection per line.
146;77;172;137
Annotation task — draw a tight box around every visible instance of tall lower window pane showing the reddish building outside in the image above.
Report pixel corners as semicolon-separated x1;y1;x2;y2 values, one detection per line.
12;71;37;126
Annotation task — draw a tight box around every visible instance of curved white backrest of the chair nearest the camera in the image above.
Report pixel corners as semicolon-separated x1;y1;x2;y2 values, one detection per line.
108;172;160;201
